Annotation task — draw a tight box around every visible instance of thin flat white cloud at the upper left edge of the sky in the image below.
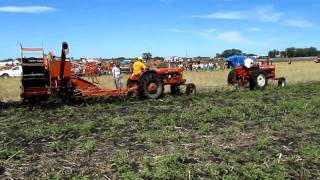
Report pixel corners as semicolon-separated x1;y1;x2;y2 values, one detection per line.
0;6;55;13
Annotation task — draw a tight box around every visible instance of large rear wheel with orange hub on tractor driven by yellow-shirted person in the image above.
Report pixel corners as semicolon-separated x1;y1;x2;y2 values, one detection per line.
139;73;164;99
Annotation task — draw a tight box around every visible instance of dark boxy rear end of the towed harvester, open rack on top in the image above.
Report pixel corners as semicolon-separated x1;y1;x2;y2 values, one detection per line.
21;45;50;101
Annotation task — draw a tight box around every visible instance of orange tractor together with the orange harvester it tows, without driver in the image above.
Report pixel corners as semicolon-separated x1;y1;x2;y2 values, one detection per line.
21;42;196;102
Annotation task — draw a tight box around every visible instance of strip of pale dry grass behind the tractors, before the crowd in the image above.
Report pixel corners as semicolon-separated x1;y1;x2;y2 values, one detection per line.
0;61;320;102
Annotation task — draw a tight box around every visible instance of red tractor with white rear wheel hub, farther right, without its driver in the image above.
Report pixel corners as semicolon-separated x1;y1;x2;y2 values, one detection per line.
227;57;286;90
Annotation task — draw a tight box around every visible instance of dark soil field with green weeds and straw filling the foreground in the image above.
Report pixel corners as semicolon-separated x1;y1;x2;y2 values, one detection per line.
0;82;320;179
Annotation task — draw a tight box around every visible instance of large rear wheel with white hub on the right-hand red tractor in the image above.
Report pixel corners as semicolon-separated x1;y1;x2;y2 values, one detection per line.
249;69;268;90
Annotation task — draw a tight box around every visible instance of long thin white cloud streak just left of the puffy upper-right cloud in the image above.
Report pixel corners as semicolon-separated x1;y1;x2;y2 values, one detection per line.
187;11;247;19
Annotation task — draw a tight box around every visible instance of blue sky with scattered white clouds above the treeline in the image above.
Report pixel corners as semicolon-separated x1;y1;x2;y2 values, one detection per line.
0;0;320;58
